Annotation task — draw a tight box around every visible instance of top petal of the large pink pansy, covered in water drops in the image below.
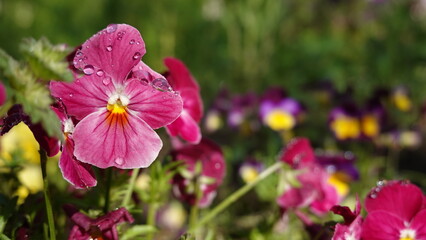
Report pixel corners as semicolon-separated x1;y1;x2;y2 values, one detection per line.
74;24;146;83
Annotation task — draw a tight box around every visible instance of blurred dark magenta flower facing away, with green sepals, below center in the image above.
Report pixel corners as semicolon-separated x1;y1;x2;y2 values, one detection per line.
172;139;226;207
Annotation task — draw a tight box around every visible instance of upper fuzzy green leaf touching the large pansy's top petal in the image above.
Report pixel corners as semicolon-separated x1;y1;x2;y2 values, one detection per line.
21;38;73;82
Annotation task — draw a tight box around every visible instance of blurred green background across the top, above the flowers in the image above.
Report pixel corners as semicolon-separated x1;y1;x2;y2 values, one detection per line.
0;0;426;102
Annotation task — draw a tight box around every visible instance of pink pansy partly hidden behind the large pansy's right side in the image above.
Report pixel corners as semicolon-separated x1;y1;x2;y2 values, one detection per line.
164;57;203;144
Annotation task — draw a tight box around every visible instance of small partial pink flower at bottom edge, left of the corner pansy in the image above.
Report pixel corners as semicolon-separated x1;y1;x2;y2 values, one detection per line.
331;197;362;240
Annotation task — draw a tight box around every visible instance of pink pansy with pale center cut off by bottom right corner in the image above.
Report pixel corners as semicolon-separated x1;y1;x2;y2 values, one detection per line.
361;181;426;240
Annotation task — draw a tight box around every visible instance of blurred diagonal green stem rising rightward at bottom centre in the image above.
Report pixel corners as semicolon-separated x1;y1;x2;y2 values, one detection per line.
190;162;283;231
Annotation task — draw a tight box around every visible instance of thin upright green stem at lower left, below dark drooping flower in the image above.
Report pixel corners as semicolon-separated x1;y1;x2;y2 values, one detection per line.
39;149;56;240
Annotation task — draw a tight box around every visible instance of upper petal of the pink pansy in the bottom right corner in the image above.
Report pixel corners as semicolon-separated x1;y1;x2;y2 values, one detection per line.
365;181;423;222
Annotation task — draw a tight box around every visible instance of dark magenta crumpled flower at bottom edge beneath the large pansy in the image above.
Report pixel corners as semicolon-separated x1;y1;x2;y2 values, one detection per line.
64;205;134;240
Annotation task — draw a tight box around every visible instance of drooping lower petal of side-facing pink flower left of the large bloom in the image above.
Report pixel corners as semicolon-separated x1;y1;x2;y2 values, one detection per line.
59;137;97;188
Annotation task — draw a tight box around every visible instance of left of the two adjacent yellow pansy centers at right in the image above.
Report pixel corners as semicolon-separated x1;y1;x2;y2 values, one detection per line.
331;117;361;140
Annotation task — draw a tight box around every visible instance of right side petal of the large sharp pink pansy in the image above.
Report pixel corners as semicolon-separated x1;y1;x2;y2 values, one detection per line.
124;79;182;129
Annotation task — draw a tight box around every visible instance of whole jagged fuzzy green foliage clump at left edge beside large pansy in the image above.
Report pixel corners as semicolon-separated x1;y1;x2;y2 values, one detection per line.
0;39;72;139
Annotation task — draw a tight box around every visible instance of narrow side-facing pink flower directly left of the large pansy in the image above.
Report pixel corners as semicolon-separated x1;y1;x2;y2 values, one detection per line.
52;105;97;188
